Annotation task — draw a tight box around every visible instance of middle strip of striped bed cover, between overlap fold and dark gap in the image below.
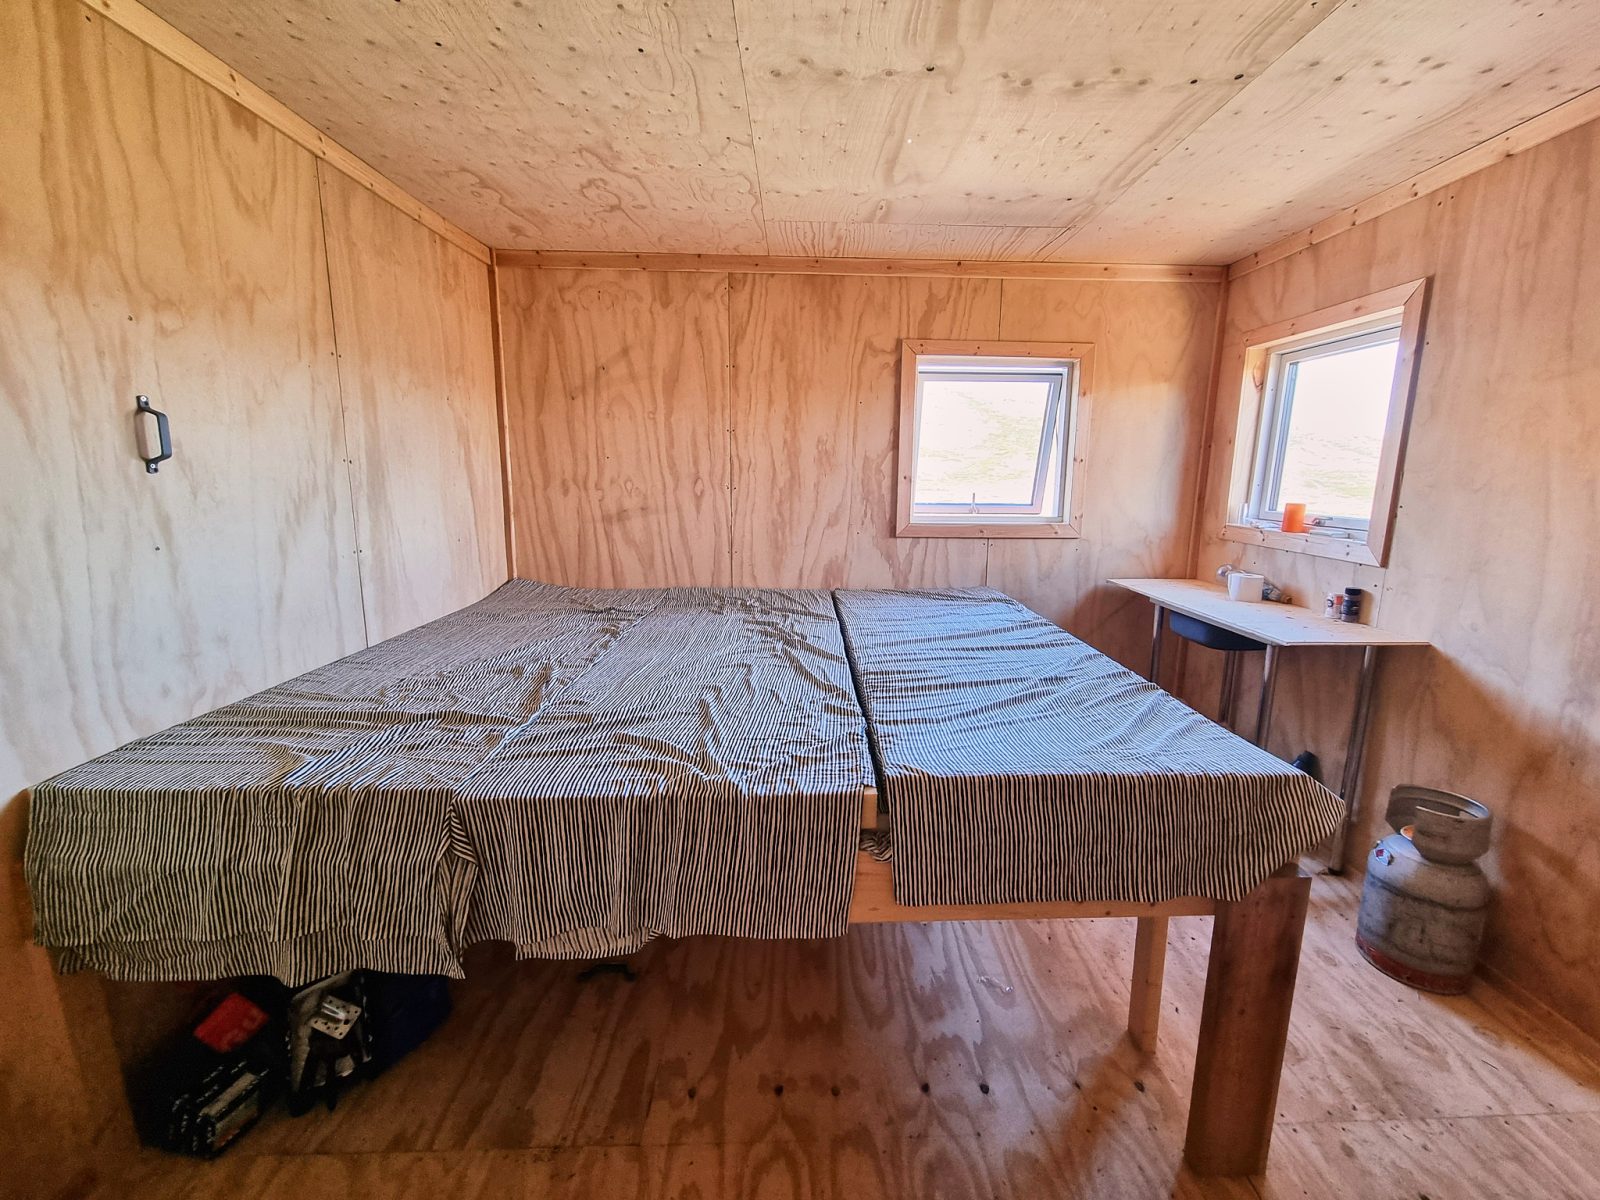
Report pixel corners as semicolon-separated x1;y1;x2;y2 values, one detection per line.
459;587;872;957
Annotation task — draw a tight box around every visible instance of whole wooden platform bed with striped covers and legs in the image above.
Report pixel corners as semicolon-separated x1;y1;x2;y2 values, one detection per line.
26;579;1341;1174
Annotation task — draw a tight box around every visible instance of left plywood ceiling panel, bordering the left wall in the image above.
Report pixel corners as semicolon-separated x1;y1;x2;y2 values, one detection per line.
144;0;766;254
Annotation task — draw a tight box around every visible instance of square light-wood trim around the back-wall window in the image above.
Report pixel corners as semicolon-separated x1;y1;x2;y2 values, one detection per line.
894;339;1094;541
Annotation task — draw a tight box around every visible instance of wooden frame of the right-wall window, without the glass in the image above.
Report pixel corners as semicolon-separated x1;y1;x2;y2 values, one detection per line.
1222;278;1427;566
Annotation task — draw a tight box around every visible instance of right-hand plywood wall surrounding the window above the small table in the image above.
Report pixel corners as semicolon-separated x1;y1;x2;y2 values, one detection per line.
1194;112;1600;1034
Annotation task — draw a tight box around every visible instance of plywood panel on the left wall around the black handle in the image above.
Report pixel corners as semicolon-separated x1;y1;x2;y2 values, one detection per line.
0;0;362;1194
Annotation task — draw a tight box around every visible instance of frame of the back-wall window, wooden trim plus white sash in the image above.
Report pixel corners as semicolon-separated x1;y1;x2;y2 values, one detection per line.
894;339;1094;539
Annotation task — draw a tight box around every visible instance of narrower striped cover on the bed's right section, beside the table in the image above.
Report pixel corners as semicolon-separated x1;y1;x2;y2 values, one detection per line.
834;589;1344;904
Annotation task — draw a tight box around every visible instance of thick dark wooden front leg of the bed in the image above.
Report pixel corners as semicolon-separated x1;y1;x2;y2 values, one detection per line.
1184;870;1310;1174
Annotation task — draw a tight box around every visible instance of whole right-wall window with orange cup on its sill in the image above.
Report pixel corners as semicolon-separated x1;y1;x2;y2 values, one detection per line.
1222;280;1426;565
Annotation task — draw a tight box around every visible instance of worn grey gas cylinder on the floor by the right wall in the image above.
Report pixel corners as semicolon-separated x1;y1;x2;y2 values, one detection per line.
1355;786;1493;995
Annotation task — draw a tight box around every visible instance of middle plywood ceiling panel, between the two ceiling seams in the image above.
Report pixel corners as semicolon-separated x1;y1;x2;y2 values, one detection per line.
736;0;1333;229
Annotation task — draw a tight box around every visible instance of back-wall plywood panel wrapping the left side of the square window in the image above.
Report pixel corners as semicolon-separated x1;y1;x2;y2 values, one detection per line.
733;275;1000;587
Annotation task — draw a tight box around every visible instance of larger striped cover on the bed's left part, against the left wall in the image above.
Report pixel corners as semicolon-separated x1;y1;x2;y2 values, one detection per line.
26;579;870;984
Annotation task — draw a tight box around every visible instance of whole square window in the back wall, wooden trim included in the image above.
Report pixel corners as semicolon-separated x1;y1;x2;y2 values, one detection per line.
898;342;1090;538
